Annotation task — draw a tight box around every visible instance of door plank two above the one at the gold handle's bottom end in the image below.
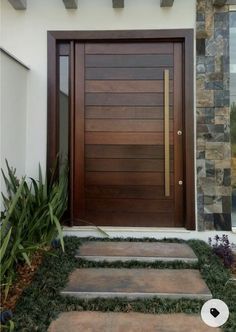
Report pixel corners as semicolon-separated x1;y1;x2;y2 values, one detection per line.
85;158;173;172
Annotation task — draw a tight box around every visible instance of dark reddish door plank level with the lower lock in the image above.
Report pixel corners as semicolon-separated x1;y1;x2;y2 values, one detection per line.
86;172;173;186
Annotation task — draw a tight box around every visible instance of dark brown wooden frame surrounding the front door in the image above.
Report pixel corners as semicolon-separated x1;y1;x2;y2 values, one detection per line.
47;29;196;230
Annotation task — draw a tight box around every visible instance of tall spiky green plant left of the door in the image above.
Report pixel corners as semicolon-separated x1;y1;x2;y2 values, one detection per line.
0;161;68;296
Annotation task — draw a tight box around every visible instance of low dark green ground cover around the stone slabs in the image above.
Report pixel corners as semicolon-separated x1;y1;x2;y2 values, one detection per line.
4;237;236;332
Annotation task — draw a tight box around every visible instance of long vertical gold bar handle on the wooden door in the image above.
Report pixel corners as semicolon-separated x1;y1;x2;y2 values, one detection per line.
164;69;170;196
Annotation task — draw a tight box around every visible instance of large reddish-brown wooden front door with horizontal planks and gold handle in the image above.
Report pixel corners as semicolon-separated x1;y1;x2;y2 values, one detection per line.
73;42;184;227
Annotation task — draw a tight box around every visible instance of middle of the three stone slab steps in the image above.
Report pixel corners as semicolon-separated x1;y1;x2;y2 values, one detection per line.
61;268;212;300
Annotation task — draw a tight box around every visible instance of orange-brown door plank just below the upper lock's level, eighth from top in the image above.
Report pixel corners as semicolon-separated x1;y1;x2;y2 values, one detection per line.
85;131;173;145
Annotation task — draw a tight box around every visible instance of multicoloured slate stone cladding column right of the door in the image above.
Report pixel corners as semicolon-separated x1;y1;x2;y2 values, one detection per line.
196;0;231;230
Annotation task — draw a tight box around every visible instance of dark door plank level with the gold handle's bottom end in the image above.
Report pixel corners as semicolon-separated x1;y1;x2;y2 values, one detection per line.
85;185;173;199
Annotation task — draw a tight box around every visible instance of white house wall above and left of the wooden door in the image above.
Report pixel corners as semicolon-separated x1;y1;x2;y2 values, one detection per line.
0;0;195;182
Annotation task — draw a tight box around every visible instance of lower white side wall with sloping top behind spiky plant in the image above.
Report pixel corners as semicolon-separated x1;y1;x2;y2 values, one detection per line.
0;52;28;208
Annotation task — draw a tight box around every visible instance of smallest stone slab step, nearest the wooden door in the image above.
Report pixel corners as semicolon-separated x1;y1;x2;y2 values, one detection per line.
76;241;197;262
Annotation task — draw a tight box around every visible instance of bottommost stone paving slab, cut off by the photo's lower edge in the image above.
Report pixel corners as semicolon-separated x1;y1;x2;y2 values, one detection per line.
48;311;221;332
